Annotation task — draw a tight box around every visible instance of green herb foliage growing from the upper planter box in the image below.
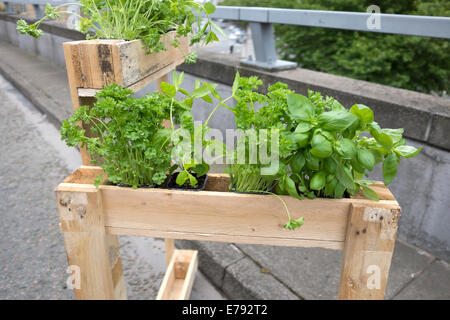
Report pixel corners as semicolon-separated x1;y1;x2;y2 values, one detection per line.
17;0;223;59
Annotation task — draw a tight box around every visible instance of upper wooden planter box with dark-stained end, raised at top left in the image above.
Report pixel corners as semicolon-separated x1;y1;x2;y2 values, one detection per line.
64;31;190;95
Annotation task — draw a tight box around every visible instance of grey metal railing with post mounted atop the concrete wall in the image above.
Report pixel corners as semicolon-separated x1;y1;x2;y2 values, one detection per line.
5;0;450;70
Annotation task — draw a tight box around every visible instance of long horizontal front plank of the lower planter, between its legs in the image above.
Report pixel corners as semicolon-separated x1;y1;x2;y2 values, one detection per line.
58;169;399;249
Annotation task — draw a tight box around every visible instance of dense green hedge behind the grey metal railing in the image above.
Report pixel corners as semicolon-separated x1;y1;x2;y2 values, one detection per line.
220;0;450;93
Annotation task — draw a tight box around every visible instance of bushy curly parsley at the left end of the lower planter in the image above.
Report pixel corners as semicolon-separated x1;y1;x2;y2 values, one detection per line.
61;84;189;188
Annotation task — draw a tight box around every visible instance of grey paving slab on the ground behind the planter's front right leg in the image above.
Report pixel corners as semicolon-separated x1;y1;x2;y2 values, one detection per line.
238;241;438;299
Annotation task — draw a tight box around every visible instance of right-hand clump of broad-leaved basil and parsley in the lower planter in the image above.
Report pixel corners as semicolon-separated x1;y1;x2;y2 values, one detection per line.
221;74;420;229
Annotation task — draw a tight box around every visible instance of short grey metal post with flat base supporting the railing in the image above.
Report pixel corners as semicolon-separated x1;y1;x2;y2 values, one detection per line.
241;22;297;71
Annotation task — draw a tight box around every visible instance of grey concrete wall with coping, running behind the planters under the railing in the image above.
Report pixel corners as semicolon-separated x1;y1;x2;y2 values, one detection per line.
0;14;450;261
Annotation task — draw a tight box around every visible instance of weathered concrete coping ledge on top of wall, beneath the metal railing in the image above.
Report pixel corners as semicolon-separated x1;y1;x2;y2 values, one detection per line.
178;50;450;150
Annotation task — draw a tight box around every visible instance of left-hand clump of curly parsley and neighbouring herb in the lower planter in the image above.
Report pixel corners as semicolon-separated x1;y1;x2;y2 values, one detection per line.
61;73;225;188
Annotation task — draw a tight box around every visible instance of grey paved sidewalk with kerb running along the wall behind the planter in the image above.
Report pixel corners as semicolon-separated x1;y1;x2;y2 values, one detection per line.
0;42;450;299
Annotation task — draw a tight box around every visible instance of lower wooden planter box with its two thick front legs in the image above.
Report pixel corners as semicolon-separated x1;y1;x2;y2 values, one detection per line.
56;167;400;299
